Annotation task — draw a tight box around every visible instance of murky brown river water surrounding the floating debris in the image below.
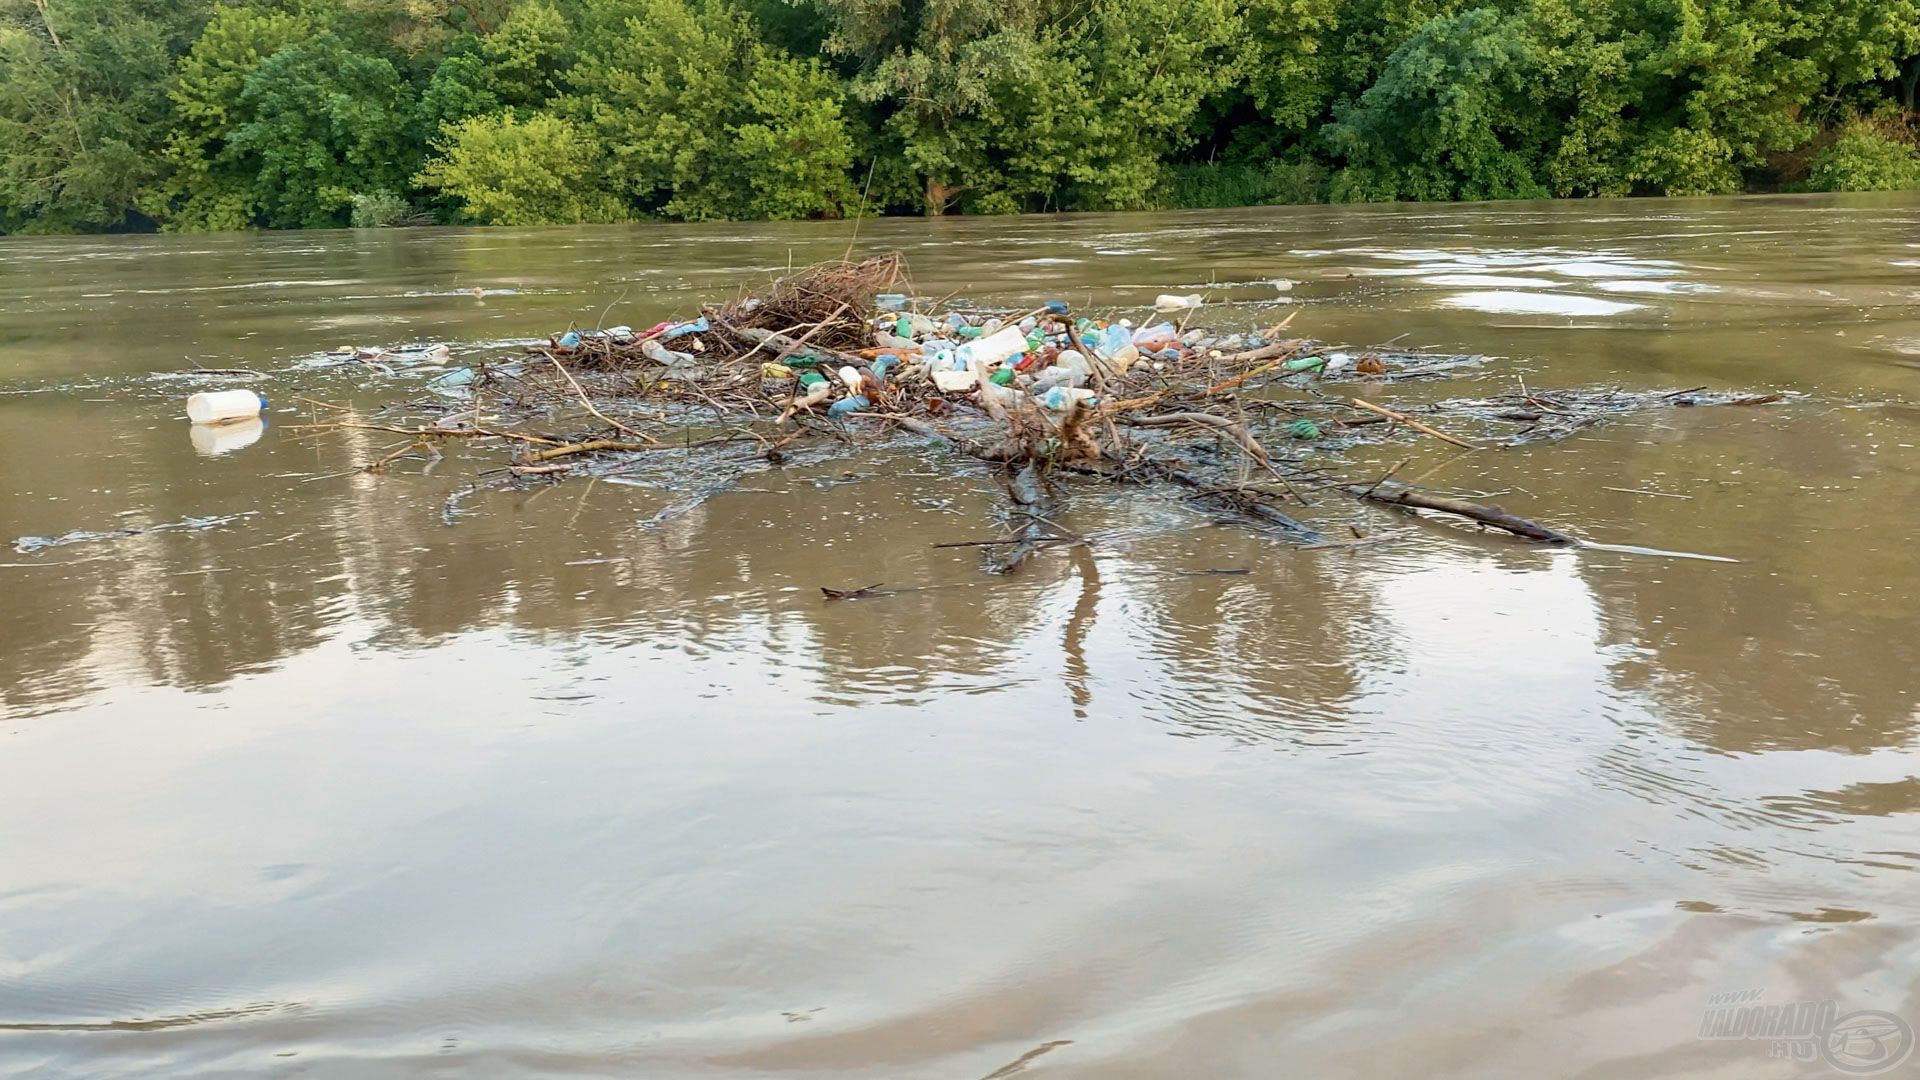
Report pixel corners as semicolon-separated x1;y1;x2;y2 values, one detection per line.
0;196;1920;1080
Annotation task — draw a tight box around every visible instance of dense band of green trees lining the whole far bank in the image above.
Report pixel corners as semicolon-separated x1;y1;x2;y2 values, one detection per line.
0;0;1920;233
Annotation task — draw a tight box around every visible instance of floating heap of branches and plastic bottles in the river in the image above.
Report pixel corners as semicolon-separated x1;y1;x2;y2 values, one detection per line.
288;256;1780;571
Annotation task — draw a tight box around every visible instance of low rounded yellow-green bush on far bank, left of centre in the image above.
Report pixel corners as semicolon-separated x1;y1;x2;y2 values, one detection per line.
417;111;624;225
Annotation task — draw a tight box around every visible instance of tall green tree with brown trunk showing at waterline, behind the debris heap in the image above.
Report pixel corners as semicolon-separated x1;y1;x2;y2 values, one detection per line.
820;0;1240;213
